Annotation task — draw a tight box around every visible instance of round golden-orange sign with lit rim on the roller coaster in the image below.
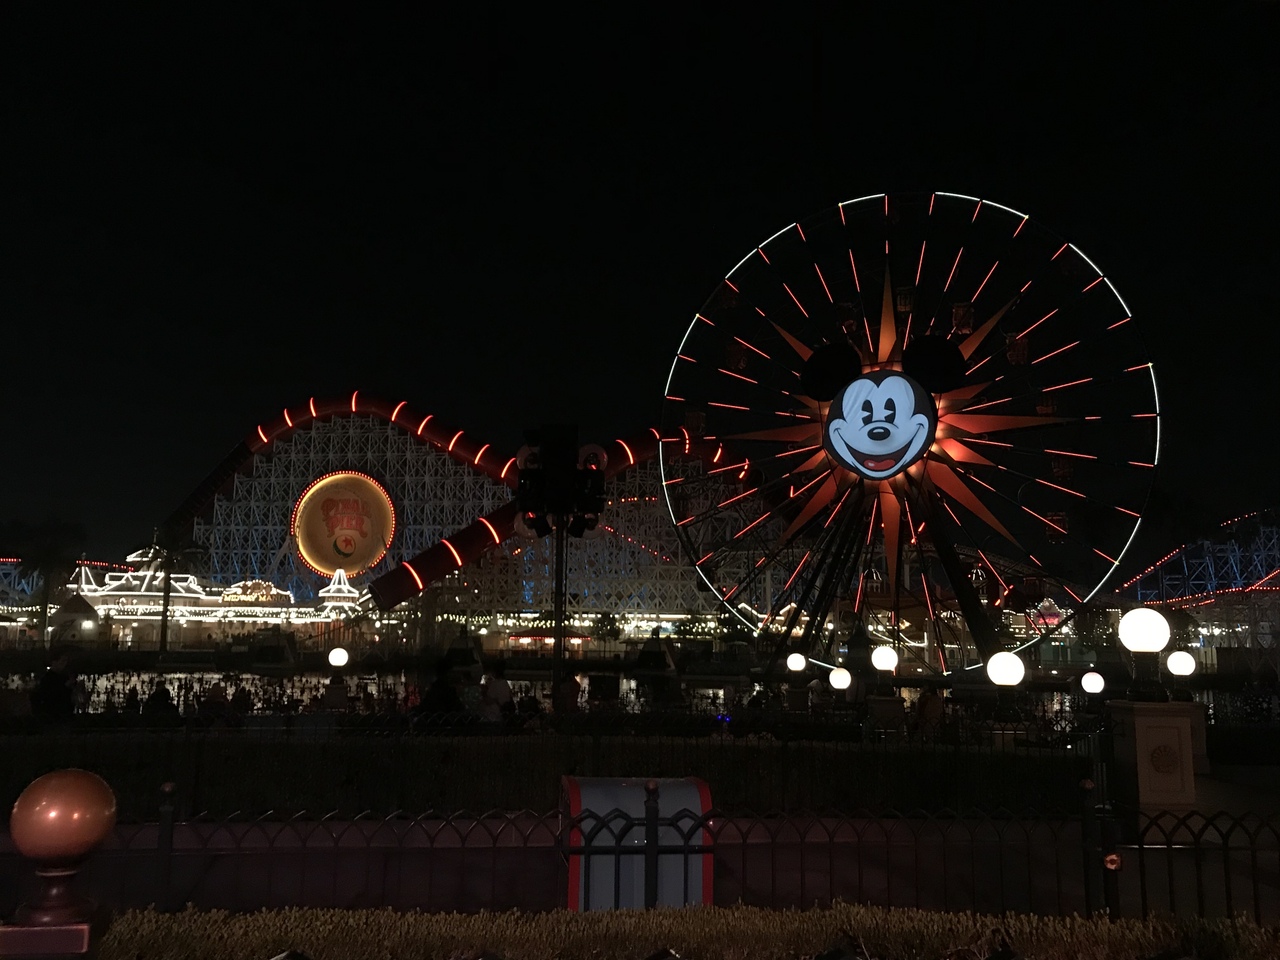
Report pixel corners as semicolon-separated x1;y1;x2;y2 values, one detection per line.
289;470;396;577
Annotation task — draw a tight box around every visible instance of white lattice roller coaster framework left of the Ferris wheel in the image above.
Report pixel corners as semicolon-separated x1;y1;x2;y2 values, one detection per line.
189;396;717;621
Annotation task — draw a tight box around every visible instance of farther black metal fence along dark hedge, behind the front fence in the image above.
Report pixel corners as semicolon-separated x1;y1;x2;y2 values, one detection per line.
0;714;1107;820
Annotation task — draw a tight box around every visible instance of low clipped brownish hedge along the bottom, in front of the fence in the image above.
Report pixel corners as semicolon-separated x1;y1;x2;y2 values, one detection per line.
101;904;1280;960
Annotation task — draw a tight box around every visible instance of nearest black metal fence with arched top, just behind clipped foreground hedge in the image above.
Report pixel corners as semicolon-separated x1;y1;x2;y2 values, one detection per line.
0;785;1280;924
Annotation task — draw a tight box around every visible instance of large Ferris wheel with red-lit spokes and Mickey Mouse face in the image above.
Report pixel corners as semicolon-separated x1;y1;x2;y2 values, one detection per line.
660;193;1160;672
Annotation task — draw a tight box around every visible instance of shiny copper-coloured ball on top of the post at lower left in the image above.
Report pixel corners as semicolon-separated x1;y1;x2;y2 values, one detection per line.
9;769;115;865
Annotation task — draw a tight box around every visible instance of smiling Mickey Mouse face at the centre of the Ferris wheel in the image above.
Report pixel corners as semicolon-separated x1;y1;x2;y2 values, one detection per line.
822;370;937;480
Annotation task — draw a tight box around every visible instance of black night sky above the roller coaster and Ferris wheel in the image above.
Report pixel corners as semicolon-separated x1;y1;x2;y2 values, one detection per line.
0;3;1280;576
